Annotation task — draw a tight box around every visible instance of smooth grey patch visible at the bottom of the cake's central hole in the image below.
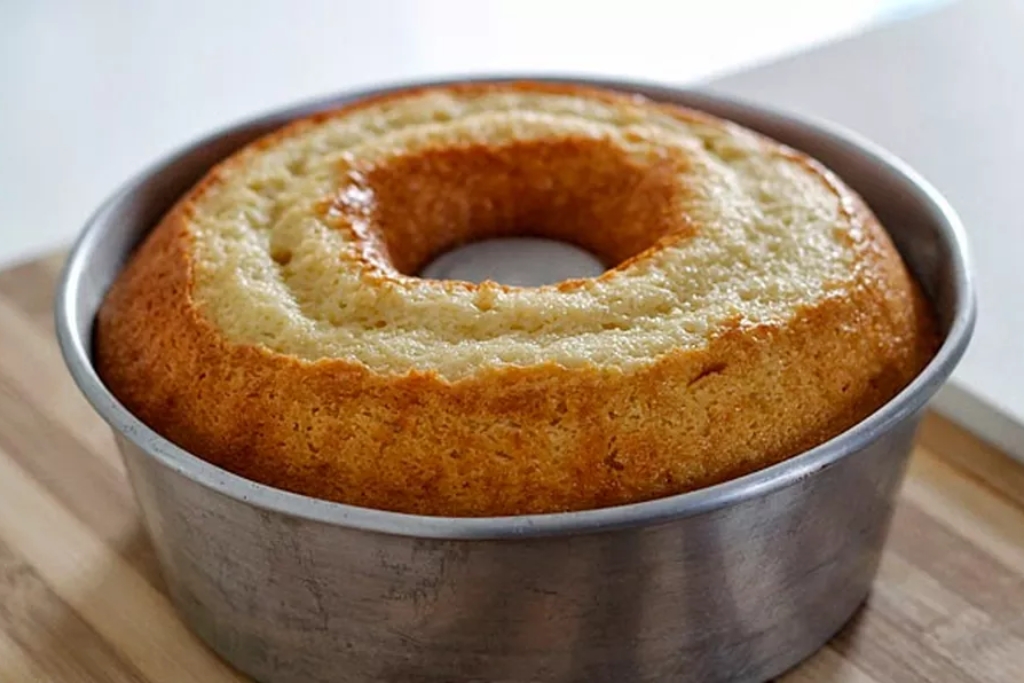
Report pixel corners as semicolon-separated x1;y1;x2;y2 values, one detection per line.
420;238;604;287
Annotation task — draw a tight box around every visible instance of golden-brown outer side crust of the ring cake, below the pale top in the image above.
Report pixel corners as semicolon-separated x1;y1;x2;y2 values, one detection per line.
96;83;935;516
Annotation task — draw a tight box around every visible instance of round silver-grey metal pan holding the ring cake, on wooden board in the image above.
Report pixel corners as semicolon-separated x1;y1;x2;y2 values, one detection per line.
56;79;975;683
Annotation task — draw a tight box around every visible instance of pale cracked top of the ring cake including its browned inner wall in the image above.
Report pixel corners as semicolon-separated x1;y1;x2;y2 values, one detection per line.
180;85;871;380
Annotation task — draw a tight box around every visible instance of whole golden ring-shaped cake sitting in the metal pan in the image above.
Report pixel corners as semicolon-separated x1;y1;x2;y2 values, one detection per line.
96;83;935;515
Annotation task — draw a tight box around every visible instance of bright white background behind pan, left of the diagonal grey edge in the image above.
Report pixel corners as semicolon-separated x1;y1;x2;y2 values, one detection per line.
0;0;921;265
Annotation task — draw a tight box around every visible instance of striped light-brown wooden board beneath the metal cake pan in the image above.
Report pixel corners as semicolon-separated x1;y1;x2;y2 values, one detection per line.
0;256;1024;683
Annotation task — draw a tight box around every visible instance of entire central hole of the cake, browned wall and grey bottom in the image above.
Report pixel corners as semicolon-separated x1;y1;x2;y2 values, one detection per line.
352;137;683;280
